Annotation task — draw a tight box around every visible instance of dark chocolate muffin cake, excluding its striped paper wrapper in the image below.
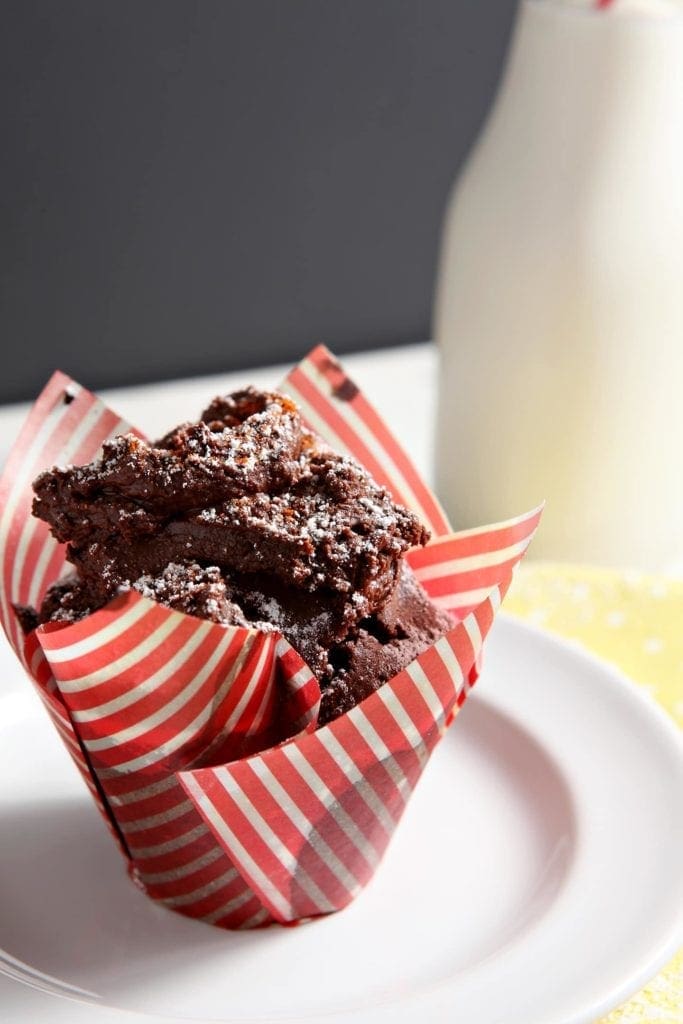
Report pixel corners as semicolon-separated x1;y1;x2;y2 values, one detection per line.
21;388;453;724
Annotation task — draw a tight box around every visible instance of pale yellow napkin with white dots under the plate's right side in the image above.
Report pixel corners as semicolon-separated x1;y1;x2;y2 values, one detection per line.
505;562;683;1024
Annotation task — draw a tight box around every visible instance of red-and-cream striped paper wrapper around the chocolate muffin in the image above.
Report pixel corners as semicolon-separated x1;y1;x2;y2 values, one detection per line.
0;346;541;928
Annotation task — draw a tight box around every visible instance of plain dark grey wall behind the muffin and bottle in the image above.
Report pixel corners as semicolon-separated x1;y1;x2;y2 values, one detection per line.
0;0;515;400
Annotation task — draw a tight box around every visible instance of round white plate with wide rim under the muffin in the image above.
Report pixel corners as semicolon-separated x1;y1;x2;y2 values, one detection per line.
0;618;683;1024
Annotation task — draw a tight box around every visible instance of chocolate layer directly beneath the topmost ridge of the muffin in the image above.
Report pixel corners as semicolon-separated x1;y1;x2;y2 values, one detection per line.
63;464;424;615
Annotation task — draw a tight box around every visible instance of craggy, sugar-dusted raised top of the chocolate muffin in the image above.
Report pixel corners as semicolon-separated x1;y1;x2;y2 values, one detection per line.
33;388;428;614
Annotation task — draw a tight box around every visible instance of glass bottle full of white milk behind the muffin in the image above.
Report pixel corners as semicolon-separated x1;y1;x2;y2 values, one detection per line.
434;0;683;569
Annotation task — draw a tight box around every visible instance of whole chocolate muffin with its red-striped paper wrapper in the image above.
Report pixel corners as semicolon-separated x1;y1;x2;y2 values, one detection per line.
0;346;541;929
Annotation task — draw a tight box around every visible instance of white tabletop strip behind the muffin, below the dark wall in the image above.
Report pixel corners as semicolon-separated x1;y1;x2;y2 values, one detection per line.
0;342;436;480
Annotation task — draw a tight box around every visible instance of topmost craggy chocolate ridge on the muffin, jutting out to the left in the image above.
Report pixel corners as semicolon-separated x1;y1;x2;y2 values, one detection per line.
33;388;311;543
